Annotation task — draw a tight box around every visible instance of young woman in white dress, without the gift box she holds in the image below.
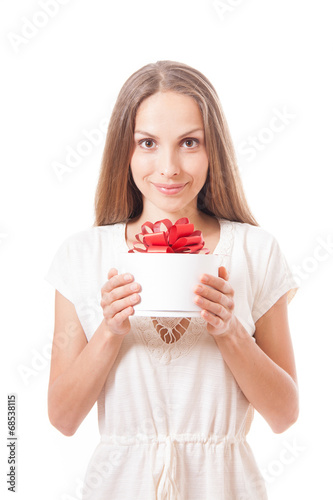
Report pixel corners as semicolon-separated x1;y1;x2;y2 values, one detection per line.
46;61;298;500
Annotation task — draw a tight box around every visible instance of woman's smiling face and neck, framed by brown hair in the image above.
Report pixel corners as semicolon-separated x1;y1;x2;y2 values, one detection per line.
131;91;208;218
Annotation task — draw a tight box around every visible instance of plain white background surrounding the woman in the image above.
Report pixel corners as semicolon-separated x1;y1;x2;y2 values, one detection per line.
0;0;333;500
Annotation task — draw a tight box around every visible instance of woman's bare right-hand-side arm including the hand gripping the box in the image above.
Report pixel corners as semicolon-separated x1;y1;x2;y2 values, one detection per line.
192;268;299;433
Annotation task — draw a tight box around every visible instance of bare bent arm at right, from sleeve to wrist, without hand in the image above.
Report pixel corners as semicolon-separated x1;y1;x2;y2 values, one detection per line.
215;294;298;433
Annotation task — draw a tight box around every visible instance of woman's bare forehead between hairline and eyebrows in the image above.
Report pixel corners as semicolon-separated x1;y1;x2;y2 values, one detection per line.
135;91;203;132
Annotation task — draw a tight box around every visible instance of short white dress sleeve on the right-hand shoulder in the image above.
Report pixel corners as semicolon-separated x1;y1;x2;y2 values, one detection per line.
252;235;299;322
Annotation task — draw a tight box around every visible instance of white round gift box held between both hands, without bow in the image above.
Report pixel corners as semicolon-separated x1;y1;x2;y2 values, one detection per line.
118;252;219;317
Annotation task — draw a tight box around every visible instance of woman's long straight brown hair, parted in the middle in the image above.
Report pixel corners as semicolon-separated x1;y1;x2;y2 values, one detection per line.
94;61;259;226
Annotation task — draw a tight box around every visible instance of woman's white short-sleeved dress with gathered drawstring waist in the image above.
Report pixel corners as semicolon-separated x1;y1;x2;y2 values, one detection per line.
45;219;298;500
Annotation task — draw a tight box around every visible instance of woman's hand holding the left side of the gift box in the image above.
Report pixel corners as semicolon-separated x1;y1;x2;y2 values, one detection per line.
101;268;141;335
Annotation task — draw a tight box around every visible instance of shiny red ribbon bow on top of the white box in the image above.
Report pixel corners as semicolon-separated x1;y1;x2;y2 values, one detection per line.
128;217;209;254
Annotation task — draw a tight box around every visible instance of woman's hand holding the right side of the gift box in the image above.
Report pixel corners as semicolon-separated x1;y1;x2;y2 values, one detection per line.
194;266;237;337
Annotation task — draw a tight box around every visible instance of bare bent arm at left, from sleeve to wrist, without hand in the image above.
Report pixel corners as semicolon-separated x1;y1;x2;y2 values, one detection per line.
48;290;123;436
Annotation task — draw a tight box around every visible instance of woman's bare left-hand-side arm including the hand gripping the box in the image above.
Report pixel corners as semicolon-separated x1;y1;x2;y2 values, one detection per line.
48;268;141;436
